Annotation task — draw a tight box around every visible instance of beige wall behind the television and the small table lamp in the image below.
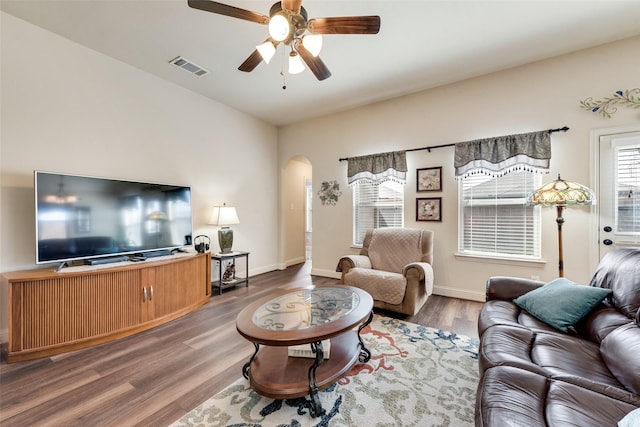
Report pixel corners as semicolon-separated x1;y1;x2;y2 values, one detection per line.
0;13;279;338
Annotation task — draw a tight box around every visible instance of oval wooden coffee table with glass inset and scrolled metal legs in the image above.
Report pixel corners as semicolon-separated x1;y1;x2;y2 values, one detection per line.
236;286;373;417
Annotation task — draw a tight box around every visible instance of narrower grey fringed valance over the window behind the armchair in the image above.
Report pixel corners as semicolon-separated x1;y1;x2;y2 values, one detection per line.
347;151;407;185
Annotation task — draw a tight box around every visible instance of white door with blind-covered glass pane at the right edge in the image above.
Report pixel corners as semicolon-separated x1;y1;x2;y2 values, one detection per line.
597;132;640;258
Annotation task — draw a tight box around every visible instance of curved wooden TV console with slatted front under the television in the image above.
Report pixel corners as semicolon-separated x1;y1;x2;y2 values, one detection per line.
2;253;211;362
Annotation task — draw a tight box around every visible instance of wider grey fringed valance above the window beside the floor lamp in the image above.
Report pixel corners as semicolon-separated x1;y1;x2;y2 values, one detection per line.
454;130;551;179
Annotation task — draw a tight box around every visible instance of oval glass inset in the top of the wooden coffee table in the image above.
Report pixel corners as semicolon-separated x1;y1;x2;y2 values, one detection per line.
252;287;360;331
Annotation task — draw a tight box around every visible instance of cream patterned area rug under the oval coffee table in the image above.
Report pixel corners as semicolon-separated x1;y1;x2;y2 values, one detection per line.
172;315;478;427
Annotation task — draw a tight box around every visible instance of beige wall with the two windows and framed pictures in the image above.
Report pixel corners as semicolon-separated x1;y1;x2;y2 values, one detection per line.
279;37;640;300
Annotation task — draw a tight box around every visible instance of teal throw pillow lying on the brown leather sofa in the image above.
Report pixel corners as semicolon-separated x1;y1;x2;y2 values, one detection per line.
513;277;612;332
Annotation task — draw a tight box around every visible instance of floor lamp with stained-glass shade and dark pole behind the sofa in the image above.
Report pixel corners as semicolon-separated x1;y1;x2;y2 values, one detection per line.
527;174;596;277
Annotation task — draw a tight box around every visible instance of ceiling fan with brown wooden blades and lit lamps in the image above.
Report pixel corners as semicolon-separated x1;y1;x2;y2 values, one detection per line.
187;0;380;80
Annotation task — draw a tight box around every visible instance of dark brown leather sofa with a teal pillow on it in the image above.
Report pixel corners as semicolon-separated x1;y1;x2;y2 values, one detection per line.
475;248;640;427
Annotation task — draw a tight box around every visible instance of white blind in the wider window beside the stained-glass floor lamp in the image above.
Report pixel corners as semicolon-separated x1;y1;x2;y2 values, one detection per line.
458;171;541;258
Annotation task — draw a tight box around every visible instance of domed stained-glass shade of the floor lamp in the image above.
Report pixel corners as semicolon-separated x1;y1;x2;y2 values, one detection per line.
527;175;596;206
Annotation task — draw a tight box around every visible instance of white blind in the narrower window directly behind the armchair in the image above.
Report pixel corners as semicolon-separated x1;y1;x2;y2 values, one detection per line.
353;181;404;246
